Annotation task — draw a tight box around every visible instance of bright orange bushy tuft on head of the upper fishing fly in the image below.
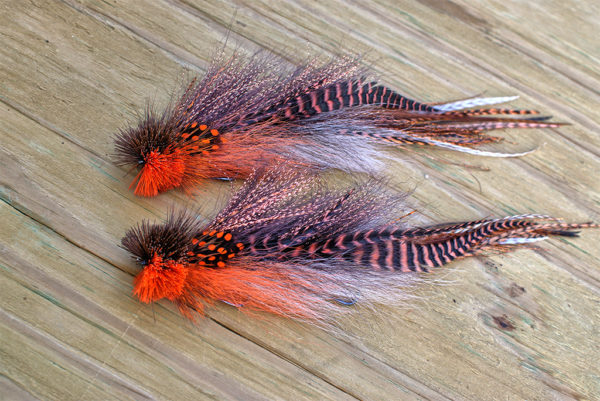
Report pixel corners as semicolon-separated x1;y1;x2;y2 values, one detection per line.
131;150;185;196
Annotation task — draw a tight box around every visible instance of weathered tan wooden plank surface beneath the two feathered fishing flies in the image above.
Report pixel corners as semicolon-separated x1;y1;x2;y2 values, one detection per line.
0;0;600;400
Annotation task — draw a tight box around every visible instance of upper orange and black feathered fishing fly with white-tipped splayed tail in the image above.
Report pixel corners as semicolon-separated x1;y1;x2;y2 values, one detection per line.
115;54;560;196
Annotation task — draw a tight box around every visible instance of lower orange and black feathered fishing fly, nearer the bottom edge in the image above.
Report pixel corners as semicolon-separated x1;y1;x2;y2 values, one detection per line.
122;169;596;322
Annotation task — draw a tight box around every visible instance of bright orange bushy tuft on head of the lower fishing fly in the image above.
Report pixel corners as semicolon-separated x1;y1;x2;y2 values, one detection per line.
133;253;188;303
